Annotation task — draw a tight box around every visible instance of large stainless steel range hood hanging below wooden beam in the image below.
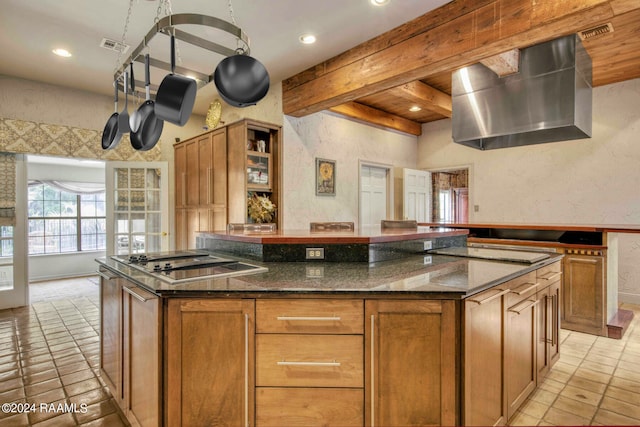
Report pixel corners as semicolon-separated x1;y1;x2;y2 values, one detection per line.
452;35;591;150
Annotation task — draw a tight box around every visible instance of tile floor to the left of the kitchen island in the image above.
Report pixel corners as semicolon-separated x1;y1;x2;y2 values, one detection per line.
0;277;128;427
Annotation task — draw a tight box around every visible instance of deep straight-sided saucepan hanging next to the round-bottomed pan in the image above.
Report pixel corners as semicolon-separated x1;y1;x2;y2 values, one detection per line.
155;34;198;126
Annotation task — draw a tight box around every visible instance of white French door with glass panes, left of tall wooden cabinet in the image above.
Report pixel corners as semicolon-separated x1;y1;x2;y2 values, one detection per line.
105;162;169;255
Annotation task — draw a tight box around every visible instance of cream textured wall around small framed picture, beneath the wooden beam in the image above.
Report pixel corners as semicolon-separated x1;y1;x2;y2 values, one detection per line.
283;112;417;229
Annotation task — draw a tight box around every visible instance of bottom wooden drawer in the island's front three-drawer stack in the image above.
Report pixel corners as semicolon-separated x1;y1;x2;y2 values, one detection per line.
256;387;364;427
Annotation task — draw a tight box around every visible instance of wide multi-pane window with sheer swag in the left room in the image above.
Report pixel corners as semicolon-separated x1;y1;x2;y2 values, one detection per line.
28;182;106;255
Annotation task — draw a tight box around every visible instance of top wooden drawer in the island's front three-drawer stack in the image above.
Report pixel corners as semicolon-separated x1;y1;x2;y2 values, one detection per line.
256;299;364;334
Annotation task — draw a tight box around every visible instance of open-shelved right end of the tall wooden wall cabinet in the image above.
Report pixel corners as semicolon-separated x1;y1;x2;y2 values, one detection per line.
227;120;282;228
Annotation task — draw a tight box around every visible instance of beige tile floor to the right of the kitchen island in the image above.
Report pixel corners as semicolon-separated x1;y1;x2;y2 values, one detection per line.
510;305;640;426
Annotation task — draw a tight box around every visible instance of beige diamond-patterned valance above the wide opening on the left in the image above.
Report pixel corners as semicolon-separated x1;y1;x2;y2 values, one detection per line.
0;118;161;161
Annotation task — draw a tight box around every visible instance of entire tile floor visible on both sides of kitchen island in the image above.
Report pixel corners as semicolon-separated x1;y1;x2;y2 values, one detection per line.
0;277;640;427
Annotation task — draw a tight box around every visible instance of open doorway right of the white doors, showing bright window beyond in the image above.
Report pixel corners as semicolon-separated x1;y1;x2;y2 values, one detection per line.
430;167;470;223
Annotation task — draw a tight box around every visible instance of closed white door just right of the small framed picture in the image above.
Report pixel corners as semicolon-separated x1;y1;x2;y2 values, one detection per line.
360;165;388;227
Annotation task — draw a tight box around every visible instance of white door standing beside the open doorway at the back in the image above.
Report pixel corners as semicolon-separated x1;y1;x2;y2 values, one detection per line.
402;169;431;222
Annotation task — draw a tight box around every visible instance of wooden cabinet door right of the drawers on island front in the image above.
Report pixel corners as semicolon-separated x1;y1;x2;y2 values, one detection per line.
365;300;459;426
